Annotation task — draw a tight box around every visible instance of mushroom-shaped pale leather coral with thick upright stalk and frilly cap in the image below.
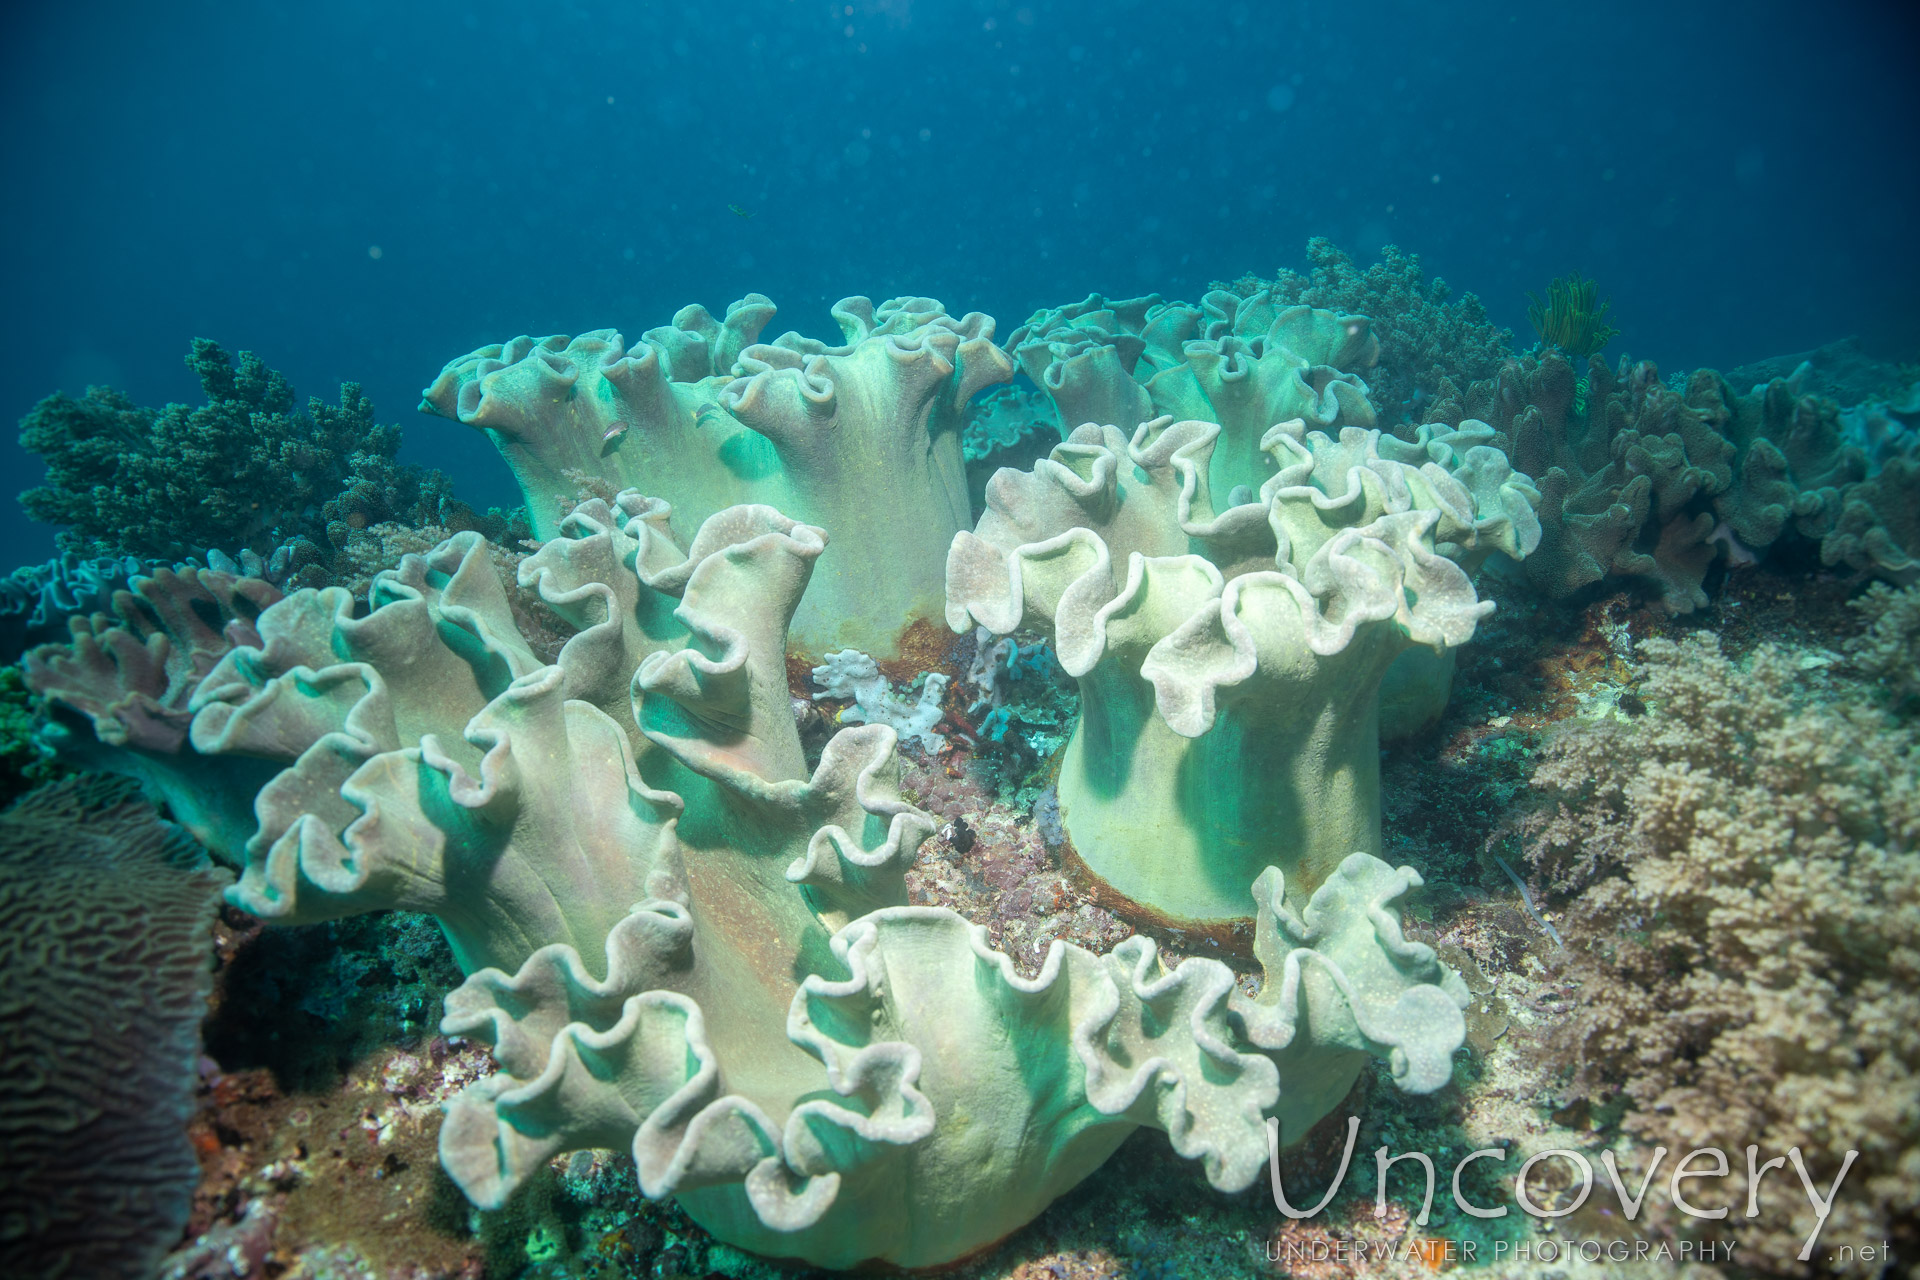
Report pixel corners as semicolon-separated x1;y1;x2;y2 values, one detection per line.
947;418;1540;923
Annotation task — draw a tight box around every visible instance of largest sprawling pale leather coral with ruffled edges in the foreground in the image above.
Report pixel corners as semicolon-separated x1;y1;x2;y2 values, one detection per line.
22;491;1465;1267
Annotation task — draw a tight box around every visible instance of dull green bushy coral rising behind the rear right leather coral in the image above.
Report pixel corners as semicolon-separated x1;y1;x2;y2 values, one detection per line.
1213;236;1513;424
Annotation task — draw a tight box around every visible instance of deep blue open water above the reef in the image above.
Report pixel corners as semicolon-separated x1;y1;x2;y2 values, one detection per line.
0;0;1920;568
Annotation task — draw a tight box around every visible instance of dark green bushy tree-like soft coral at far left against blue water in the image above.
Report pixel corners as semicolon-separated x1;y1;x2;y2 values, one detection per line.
19;338;468;560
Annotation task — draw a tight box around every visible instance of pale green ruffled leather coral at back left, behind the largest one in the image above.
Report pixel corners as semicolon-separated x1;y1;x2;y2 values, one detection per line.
420;294;1012;656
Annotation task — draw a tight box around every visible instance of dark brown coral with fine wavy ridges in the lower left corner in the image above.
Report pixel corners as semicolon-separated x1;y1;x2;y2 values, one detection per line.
0;777;227;1280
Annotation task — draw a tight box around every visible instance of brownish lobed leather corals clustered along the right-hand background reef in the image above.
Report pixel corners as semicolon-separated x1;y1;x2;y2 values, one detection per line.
1434;351;1920;612
